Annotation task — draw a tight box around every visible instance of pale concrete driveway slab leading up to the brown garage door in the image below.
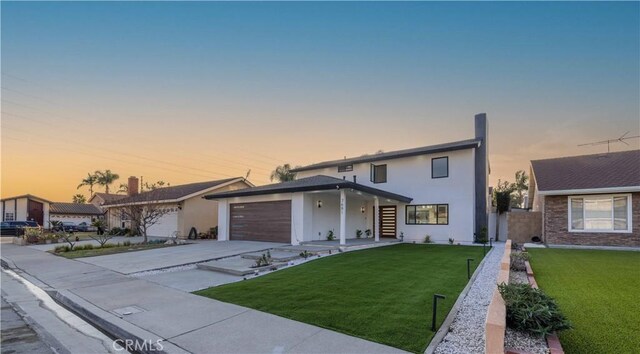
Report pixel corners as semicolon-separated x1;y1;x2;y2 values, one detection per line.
76;240;285;274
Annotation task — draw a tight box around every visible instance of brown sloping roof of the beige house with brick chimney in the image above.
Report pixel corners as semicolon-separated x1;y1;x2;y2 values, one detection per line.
103;177;245;206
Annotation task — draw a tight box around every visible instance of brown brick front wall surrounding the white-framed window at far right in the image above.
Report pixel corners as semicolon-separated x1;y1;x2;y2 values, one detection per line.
543;193;640;247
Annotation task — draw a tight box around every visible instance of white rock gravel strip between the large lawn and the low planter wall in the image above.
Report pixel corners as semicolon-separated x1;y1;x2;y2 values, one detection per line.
435;243;504;354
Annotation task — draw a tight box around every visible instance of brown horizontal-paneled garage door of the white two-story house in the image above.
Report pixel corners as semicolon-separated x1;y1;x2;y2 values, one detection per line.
229;200;291;243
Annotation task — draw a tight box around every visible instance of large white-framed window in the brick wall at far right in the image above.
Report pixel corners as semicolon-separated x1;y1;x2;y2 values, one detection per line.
569;195;631;232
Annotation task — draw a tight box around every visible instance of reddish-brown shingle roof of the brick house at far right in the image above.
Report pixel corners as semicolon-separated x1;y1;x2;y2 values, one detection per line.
531;150;640;192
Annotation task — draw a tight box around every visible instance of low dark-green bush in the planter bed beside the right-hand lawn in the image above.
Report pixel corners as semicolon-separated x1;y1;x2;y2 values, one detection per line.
498;283;571;336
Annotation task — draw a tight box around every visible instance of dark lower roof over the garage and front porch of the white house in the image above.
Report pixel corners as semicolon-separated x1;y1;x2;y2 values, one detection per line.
205;175;412;203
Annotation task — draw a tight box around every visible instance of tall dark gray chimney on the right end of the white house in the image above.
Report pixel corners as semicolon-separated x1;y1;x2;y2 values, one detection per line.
475;113;493;238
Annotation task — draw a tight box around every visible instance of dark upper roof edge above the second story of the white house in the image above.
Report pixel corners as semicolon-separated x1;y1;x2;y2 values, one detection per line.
291;139;482;172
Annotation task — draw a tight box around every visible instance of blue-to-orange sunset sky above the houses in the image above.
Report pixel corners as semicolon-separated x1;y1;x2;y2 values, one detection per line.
0;1;640;201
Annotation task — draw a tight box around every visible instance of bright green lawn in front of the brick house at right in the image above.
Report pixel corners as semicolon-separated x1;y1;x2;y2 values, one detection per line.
528;249;640;353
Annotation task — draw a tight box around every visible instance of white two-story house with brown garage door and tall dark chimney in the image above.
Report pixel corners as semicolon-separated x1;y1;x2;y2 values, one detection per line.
205;114;490;245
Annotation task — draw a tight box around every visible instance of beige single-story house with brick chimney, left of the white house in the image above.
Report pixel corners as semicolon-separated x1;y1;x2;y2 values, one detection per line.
101;177;253;237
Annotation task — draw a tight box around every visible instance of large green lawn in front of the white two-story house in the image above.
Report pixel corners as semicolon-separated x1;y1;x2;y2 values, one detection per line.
195;244;483;352
